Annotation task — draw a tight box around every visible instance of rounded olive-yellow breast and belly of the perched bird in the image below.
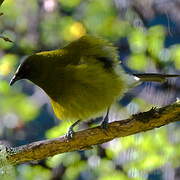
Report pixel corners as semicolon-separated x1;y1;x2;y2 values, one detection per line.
45;64;125;121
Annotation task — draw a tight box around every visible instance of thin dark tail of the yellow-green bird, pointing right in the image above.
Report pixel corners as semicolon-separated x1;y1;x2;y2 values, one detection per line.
133;73;180;83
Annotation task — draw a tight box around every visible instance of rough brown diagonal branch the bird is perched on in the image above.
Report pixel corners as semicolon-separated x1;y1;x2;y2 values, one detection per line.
2;102;180;164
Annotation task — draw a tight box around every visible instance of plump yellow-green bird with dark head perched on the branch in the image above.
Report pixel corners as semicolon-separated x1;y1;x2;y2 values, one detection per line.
10;35;180;138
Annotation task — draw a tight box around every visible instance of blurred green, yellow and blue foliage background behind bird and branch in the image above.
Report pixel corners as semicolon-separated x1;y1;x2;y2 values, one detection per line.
0;0;180;180
